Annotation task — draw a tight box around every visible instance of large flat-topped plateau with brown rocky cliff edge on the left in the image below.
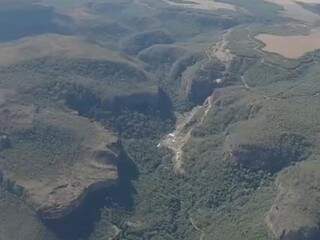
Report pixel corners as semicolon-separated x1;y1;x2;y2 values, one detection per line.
0;91;121;219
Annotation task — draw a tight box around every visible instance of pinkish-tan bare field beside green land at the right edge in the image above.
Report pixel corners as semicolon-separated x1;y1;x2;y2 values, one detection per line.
256;31;320;59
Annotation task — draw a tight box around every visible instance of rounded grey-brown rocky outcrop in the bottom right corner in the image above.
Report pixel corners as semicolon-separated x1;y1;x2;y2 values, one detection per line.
266;162;320;240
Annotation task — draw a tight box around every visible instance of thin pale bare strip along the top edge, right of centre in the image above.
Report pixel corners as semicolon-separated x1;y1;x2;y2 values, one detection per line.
163;0;236;11
